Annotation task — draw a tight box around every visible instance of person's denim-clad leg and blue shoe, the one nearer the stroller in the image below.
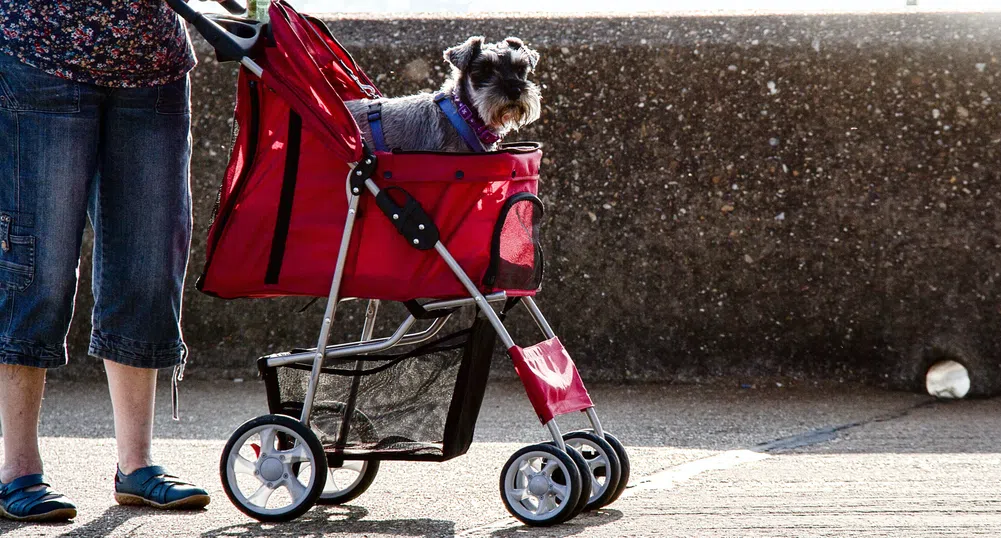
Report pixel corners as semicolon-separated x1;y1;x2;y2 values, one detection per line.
90;78;208;508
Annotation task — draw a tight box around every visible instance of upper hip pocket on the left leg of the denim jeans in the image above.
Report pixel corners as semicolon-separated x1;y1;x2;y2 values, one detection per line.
0;56;80;113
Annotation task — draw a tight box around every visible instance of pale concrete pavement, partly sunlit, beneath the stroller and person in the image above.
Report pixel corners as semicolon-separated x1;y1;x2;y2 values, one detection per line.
0;374;1001;537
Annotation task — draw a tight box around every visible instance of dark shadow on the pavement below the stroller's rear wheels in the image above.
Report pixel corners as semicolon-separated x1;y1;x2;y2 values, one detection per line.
201;505;455;538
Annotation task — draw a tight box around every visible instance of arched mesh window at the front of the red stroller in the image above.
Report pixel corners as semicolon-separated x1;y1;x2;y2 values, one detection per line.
491;197;543;291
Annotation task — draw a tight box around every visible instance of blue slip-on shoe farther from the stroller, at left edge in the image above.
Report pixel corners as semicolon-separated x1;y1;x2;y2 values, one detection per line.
0;475;76;522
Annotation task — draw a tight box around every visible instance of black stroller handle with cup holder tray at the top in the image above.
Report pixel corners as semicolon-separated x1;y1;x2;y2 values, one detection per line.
165;0;263;61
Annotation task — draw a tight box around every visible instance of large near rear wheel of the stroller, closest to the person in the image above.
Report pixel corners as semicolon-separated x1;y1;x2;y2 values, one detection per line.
219;415;327;522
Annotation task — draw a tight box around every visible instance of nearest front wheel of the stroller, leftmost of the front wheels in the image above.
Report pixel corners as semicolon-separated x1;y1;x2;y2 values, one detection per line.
501;443;584;527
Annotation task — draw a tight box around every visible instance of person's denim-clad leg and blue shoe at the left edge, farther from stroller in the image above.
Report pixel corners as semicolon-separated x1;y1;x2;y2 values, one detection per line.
0;56;101;518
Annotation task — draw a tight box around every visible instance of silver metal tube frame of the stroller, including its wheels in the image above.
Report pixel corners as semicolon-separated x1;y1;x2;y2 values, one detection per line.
167;0;629;525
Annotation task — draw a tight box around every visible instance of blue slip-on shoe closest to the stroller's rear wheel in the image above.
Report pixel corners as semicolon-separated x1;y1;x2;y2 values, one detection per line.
115;465;209;510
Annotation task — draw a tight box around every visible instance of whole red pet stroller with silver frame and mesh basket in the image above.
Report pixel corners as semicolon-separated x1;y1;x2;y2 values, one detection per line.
167;0;629;525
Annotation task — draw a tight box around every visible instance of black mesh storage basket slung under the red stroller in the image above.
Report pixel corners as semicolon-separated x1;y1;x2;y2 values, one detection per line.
258;319;495;461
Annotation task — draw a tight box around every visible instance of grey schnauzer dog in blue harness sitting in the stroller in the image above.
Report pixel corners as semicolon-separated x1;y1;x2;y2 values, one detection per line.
345;36;542;151
